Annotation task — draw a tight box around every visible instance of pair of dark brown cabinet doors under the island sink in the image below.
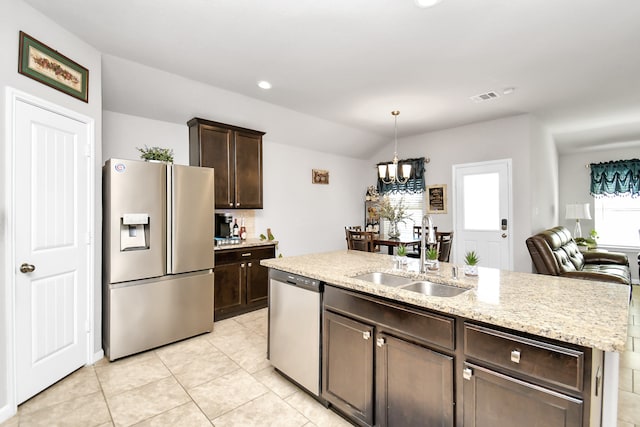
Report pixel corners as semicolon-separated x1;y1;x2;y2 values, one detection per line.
323;311;454;427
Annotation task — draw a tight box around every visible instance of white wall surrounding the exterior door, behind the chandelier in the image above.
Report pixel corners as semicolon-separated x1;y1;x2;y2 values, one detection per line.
372;115;539;272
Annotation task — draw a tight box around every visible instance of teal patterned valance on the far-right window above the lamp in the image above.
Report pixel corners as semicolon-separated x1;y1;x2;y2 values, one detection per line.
589;159;640;197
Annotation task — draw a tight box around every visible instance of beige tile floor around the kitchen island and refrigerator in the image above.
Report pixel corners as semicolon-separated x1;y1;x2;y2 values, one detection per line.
2;286;640;427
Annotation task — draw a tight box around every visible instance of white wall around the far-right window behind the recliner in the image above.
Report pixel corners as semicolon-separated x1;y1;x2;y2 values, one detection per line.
559;146;639;283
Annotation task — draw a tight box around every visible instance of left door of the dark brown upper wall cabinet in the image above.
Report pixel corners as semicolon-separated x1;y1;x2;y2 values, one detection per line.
200;125;236;209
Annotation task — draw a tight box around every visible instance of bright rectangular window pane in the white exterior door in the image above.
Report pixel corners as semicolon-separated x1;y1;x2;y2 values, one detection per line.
463;173;500;231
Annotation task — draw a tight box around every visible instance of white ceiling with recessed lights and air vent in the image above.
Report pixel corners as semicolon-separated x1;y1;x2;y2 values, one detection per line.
25;0;640;154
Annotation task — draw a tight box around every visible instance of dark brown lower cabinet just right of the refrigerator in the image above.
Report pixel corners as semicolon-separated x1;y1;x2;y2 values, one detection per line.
213;246;275;320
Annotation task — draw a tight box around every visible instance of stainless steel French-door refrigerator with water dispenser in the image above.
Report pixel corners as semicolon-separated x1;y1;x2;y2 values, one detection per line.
102;159;214;360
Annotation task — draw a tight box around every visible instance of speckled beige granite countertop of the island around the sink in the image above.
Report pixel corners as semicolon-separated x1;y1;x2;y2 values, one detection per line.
261;250;629;352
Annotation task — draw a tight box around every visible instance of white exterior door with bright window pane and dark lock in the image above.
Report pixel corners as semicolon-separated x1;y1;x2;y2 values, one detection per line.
453;159;513;270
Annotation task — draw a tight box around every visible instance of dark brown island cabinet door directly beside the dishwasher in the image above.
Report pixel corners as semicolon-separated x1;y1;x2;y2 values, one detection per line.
322;311;374;425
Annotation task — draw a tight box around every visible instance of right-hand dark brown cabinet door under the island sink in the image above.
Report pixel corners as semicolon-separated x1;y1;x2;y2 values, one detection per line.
376;334;456;426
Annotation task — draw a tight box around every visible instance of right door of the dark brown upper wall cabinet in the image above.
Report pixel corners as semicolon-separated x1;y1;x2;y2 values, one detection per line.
232;131;262;209
